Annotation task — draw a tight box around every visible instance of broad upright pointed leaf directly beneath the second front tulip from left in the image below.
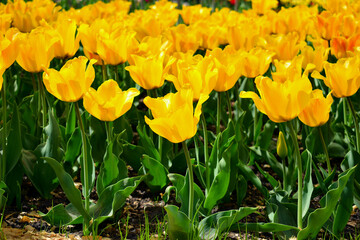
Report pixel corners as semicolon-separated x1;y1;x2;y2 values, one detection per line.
96;143;128;195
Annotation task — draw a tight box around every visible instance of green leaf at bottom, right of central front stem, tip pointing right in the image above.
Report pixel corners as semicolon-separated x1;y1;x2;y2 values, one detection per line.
198;207;257;240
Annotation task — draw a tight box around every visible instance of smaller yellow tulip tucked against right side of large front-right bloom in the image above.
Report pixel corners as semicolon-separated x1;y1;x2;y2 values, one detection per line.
299;89;333;127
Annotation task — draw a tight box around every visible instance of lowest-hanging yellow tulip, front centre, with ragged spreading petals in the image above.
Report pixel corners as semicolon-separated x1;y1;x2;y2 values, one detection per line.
144;89;208;143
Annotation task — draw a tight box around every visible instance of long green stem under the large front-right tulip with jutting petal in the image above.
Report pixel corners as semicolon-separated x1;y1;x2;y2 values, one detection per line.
288;121;303;229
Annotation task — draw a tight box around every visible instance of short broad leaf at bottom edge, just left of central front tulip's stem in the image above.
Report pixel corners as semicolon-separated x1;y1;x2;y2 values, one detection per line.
164;205;193;240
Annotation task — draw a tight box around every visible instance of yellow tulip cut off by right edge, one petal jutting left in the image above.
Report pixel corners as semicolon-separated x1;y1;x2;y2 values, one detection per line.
311;55;360;98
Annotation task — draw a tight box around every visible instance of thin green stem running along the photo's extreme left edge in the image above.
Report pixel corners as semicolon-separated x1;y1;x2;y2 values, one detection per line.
0;74;7;181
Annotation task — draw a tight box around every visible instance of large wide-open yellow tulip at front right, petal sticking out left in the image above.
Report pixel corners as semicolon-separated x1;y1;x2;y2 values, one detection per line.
240;76;312;123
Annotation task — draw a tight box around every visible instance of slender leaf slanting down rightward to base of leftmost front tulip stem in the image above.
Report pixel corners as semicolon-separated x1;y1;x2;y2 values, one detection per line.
43;157;90;219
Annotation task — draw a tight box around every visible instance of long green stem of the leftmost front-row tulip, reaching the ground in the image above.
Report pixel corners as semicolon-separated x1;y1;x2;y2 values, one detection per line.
75;102;90;233
